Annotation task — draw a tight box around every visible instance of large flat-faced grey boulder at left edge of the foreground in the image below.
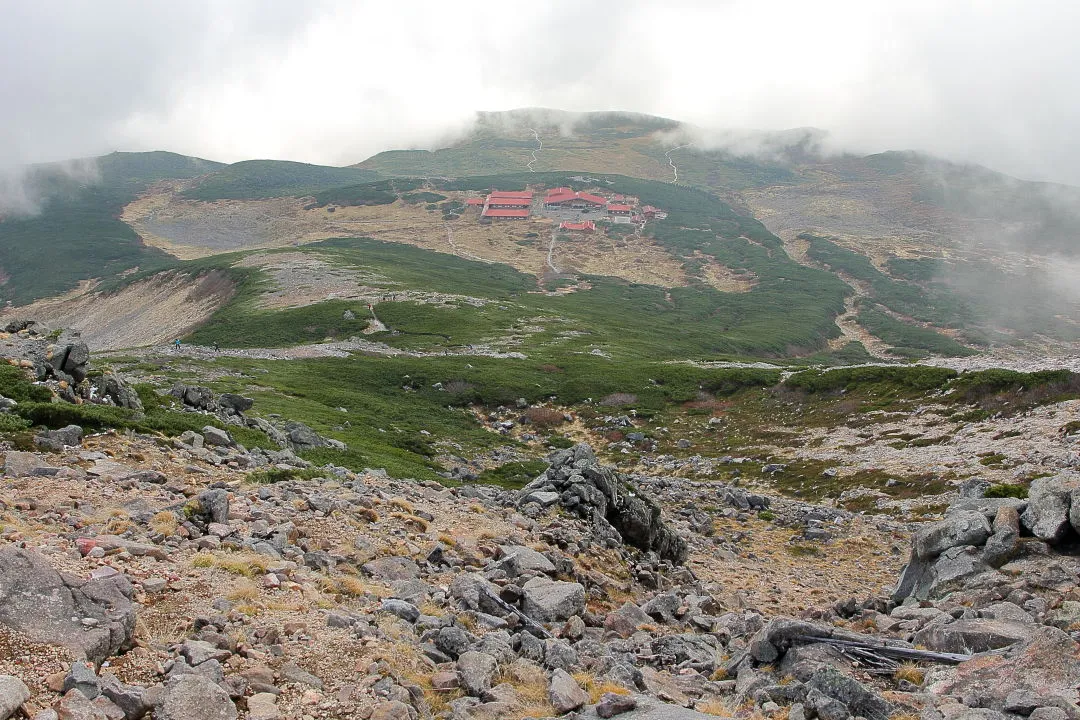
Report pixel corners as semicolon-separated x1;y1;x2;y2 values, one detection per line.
0;545;135;665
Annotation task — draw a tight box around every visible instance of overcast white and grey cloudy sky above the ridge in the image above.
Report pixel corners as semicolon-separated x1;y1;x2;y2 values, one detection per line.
8;0;1080;185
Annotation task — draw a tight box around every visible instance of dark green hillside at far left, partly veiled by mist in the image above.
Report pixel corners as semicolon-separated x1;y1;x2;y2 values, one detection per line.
0;152;222;304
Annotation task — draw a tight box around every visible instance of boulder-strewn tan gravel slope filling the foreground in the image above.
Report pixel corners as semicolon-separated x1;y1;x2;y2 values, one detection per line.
0;328;1080;720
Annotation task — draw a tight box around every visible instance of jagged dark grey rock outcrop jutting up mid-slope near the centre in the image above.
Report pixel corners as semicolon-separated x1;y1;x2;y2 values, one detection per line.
518;444;689;563
